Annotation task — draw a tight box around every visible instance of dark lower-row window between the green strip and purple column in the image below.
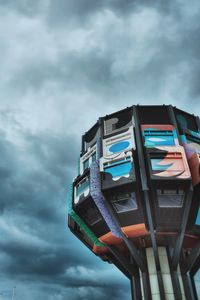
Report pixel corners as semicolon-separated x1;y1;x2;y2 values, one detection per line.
81;202;102;226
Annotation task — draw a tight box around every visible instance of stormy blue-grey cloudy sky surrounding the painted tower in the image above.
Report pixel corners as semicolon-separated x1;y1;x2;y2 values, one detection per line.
0;0;200;300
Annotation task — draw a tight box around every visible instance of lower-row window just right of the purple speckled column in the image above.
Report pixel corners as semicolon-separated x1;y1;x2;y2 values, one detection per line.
111;193;137;213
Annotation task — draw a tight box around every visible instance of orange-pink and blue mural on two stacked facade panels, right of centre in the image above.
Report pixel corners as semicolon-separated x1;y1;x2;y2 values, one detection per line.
141;125;190;179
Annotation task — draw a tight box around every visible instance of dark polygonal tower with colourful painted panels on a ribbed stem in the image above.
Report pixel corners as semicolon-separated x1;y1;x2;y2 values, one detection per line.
68;105;200;300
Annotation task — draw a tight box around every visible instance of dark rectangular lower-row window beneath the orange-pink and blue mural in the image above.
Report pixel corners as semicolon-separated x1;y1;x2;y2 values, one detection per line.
157;189;185;207
